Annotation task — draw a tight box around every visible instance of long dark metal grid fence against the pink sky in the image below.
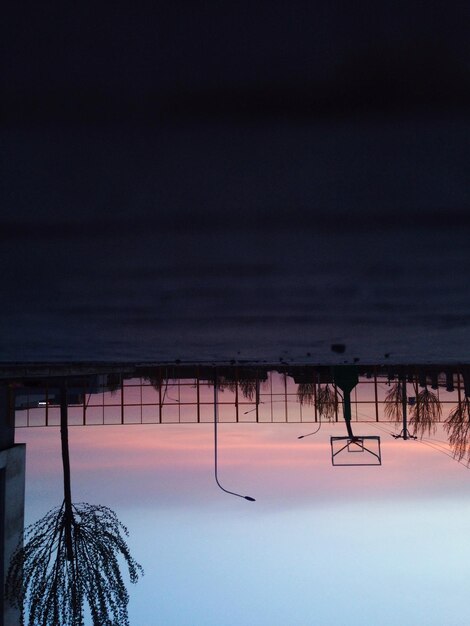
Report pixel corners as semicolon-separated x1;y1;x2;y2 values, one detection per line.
12;371;464;428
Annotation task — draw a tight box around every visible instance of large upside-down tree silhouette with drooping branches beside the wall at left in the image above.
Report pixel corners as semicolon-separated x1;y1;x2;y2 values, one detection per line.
5;386;143;626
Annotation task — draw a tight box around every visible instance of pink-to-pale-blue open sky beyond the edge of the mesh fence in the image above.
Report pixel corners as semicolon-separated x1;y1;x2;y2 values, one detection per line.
17;424;470;626
